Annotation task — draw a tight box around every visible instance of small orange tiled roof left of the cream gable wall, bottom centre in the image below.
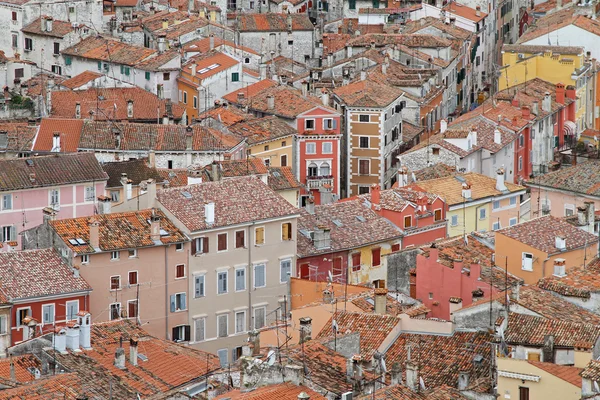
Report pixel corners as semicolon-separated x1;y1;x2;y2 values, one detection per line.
317;311;400;360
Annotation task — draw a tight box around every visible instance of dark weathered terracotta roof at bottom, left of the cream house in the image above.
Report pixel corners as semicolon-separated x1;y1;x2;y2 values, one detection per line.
386;331;492;388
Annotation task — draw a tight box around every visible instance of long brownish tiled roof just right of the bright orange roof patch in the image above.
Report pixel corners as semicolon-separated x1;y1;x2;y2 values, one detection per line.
79;121;243;153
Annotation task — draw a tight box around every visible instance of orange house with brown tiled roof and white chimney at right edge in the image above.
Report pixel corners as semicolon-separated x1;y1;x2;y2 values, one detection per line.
495;215;598;284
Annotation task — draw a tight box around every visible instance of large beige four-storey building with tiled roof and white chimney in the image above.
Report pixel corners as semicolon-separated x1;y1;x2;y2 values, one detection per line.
157;176;298;365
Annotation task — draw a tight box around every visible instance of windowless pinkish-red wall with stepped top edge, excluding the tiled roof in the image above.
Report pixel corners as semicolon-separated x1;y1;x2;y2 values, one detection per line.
416;249;499;320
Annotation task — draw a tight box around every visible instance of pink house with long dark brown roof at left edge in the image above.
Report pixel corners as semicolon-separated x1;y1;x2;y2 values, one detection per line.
0;153;108;252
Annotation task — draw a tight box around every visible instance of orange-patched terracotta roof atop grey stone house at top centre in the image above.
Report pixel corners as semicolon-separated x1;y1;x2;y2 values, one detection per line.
238;14;314;32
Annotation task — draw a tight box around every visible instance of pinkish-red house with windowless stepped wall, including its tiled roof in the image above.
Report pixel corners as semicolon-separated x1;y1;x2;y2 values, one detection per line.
416;235;520;320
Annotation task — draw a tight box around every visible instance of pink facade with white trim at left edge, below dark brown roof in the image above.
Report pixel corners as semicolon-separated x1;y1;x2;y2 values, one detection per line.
0;181;106;251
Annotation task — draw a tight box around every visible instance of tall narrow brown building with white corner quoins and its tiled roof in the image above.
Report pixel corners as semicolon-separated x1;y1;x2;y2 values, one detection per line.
333;73;405;197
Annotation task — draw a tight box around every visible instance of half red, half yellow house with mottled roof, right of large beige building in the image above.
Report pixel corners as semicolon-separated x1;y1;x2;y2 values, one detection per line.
296;199;402;284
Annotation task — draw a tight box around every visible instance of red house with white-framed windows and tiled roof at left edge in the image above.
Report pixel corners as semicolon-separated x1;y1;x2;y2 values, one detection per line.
0;249;92;345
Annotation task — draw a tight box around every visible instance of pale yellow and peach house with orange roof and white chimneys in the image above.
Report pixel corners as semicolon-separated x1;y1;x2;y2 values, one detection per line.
409;170;525;237
